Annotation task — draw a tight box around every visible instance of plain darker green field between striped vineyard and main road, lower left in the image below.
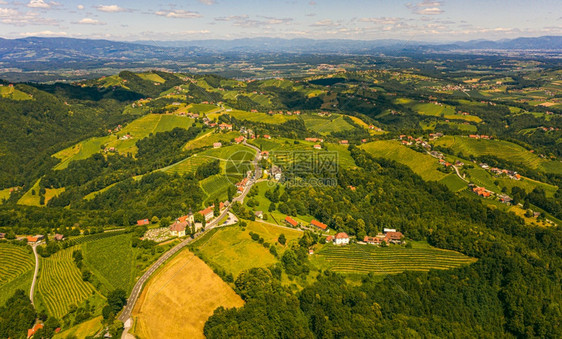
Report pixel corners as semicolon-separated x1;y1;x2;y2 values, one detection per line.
82;233;135;291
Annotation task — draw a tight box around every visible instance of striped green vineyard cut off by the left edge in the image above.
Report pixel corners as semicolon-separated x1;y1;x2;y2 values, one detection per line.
0;243;35;305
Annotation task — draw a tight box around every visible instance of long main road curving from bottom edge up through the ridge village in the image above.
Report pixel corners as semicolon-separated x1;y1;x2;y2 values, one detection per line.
119;141;261;338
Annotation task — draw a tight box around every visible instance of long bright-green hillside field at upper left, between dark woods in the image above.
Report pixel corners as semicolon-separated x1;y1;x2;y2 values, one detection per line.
53;114;193;169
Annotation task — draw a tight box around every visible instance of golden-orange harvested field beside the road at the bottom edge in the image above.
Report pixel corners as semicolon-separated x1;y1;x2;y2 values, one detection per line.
132;250;244;338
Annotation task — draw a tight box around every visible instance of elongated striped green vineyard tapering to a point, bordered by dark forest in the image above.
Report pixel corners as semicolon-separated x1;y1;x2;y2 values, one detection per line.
313;243;476;274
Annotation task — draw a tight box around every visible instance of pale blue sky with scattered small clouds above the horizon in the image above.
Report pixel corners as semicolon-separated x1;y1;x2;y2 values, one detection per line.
0;0;562;41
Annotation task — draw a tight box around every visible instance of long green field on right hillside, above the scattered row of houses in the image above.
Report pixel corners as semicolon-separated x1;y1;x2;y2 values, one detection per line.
435;136;562;174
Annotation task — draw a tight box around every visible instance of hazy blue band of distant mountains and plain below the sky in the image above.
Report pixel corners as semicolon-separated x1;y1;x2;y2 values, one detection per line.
0;36;562;81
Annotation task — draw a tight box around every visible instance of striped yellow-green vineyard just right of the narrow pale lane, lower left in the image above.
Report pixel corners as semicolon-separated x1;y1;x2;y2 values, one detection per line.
37;246;96;319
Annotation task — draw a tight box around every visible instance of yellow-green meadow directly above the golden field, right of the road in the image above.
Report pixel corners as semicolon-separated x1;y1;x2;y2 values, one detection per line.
192;222;302;277
